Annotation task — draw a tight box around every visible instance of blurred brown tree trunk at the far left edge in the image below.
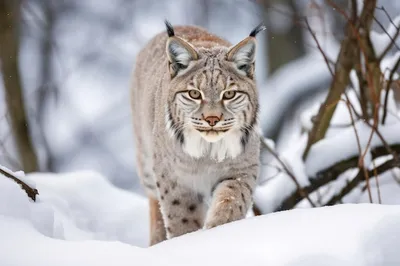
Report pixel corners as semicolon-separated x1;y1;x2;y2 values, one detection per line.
0;0;38;172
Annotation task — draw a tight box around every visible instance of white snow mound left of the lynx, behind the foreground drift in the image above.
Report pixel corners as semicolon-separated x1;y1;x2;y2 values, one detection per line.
0;171;149;247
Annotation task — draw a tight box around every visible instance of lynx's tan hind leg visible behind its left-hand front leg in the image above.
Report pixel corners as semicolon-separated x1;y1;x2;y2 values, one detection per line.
149;197;167;246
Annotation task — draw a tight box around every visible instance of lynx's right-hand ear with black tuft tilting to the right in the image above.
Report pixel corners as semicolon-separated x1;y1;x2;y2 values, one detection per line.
227;24;266;78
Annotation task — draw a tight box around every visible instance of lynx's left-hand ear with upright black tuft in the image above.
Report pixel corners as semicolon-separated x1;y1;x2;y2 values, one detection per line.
165;21;199;78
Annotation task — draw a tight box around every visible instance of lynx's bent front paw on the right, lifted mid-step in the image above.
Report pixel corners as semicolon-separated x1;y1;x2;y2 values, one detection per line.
204;197;244;229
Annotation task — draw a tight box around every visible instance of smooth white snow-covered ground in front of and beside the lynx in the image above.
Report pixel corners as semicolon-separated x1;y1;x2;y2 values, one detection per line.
0;169;400;266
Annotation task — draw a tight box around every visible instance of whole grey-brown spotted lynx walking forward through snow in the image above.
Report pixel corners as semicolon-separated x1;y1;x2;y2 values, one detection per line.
131;21;265;245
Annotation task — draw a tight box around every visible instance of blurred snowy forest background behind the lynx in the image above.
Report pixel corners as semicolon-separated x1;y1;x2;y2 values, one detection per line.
0;0;400;206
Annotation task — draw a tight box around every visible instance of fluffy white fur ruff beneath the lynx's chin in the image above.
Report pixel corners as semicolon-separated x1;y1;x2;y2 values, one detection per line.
183;129;243;162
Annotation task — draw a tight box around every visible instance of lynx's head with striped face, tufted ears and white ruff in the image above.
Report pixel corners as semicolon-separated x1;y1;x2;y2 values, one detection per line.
166;21;265;160
